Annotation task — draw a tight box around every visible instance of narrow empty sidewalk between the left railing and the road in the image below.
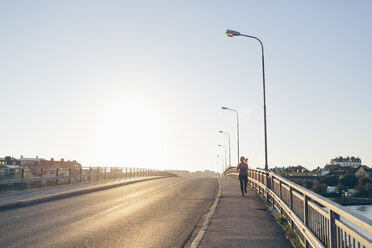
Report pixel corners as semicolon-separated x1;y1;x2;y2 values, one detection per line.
0;176;163;210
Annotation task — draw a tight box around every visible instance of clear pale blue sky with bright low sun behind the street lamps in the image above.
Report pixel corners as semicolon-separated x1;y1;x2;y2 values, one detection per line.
0;0;372;171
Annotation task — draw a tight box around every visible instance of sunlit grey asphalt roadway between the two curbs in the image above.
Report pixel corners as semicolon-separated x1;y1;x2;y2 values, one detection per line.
0;177;218;247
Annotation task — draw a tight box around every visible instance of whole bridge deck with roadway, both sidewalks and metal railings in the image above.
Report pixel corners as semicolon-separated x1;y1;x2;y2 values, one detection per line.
0;167;372;247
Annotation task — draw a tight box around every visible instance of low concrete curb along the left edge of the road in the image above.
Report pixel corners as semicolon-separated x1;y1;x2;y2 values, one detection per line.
0;176;165;210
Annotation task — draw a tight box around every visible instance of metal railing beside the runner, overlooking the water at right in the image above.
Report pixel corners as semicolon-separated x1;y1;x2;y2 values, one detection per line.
225;167;372;248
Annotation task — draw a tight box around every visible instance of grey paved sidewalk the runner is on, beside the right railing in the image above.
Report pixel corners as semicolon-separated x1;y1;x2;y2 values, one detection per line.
199;177;292;248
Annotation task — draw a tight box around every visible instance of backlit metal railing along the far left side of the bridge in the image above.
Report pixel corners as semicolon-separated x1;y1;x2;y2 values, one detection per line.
0;167;172;188
